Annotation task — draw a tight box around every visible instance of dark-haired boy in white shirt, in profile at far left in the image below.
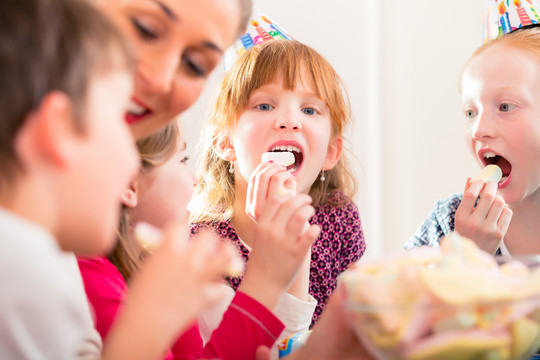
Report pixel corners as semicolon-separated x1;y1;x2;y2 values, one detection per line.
0;0;236;359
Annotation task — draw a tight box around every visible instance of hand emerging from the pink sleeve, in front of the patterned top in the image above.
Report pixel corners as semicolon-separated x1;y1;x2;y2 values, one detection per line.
239;194;320;310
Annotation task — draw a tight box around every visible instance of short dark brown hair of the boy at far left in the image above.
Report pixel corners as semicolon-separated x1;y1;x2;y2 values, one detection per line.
0;0;132;186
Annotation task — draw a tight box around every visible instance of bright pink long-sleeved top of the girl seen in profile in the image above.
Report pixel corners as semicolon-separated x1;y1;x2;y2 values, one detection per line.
78;257;284;360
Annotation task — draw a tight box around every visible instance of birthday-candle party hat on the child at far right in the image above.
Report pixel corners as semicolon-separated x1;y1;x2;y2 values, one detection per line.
482;0;540;42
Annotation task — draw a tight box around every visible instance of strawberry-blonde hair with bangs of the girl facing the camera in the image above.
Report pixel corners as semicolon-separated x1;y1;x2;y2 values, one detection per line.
190;40;356;222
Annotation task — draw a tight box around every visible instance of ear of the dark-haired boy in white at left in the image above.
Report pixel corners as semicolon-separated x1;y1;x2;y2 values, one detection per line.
15;91;81;167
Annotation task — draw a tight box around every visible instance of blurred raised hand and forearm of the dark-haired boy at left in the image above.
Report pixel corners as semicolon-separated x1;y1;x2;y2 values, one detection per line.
107;224;231;359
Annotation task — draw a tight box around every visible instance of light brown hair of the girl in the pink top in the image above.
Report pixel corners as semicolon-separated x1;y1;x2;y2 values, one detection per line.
107;121;180;282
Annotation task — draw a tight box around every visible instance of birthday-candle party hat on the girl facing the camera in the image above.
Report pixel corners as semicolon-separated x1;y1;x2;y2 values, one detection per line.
223;7;294;71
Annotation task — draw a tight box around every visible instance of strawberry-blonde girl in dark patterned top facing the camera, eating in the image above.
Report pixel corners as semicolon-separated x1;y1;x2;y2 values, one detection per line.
190;40;365;330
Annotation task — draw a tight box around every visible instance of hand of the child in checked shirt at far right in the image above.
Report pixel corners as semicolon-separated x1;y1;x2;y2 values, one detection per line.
455;179;512;254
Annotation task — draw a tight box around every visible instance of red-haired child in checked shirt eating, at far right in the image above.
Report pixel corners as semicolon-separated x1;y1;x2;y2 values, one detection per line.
405;27;540;255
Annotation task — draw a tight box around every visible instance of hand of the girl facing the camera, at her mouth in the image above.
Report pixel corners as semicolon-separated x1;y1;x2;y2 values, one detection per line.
246;162;296;222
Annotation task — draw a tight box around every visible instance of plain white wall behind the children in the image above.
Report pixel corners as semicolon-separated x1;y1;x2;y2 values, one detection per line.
182;0;484;257
